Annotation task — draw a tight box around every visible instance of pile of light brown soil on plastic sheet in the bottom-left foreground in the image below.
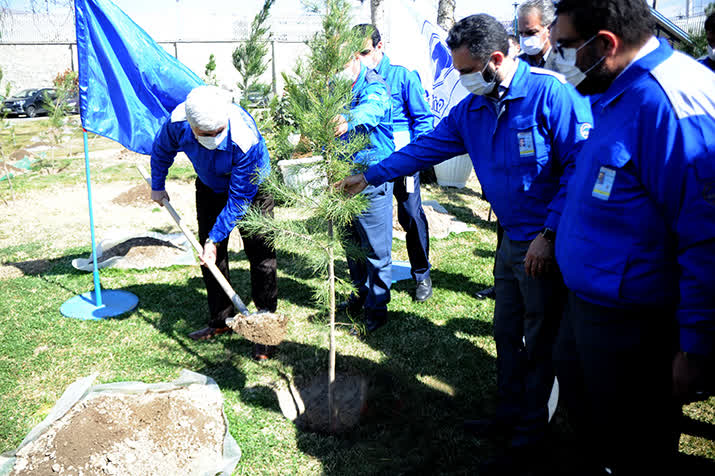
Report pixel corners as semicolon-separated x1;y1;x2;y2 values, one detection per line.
10;385;226;475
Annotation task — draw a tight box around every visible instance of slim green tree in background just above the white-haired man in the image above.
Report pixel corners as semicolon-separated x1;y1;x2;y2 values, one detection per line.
233;0;275;107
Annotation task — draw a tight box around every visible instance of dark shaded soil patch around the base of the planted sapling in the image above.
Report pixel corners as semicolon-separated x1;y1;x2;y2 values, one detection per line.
295;374;368;433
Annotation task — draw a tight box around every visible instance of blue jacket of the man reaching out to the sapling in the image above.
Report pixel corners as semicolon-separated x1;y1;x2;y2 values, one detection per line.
365;60;592;241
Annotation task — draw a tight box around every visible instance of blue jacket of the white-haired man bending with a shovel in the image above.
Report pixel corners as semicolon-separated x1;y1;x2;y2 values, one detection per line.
151;103;270;243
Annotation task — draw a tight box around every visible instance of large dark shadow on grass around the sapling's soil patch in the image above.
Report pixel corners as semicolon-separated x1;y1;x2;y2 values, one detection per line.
235;312;495;474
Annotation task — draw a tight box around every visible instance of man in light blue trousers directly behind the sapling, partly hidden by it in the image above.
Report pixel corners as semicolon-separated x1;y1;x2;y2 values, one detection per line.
335;48;395;333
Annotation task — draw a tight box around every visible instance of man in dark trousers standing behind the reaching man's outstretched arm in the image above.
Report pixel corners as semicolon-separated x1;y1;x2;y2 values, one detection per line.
356;24;434;302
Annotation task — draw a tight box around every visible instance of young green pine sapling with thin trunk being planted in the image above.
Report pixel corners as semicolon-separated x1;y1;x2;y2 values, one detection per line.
241;0;369;431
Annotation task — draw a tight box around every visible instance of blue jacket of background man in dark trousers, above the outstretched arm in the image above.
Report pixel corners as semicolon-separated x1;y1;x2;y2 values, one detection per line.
375;55;434;139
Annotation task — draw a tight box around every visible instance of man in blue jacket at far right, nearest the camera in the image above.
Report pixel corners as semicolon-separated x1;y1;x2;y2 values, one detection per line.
554;0;715;475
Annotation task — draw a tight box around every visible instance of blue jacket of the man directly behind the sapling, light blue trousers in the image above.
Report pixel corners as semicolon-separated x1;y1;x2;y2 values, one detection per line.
341;64;395;165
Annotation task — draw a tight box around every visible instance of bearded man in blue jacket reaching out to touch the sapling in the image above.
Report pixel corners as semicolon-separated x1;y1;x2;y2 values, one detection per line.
336;15;591;463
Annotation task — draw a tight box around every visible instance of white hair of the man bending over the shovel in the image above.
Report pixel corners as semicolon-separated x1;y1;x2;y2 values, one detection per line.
185;86;231;132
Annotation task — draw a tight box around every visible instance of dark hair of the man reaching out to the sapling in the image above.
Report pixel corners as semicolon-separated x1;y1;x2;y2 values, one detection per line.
447;13;509;62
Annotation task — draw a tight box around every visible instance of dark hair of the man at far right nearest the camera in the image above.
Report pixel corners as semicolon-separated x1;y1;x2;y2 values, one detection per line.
556;0;655;46
